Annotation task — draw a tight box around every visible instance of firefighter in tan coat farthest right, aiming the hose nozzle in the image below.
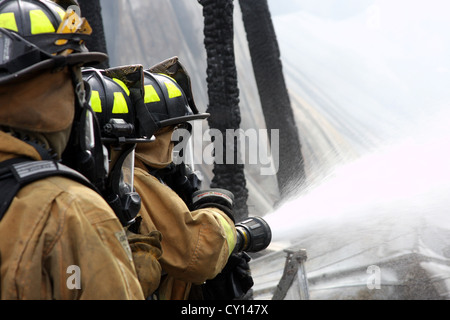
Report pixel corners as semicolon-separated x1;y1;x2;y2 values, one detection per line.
129;57;236;300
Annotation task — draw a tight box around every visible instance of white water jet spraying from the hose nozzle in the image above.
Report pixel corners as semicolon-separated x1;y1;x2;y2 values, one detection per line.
265;109;450;246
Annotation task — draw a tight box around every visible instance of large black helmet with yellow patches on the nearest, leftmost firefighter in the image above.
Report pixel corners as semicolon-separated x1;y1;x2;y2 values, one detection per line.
0;0;107;84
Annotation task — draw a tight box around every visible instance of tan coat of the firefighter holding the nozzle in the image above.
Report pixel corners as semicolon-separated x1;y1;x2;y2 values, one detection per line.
134;159;236;300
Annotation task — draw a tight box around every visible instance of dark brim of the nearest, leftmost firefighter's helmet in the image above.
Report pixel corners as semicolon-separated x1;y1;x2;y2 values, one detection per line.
0;52;108;85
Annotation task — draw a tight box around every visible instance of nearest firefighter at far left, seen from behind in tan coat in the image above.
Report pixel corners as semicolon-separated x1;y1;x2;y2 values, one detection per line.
0;0;144;300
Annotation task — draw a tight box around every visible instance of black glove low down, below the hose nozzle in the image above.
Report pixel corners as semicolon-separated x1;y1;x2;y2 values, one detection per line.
202;252;253;300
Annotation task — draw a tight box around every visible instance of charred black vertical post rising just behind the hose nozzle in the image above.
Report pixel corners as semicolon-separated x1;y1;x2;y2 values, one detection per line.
198;0;248;221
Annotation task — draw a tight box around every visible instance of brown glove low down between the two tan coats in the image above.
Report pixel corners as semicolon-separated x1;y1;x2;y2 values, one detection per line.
127;230;162;298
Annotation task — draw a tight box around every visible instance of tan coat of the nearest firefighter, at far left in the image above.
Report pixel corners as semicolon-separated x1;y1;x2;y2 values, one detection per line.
0;131;144;300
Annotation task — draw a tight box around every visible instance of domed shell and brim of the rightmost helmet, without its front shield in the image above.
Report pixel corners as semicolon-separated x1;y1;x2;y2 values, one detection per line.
144;70;209;128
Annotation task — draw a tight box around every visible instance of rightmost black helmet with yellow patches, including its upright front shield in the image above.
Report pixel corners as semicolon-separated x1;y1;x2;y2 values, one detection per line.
144;57;209;128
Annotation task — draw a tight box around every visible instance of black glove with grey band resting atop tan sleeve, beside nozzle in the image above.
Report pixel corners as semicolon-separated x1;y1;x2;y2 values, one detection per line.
190;188;235;222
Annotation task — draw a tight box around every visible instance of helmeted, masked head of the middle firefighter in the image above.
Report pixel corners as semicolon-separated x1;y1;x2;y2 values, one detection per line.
82;67;154;226
